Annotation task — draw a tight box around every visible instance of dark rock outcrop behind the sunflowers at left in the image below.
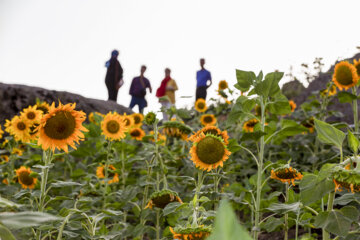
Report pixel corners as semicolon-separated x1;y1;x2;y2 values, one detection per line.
0;83;132;124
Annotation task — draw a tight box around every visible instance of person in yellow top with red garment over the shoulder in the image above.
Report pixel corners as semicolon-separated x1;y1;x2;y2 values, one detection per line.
156;68;178;121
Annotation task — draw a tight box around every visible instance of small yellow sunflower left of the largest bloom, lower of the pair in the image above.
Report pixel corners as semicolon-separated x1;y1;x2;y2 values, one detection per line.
9;116;31;142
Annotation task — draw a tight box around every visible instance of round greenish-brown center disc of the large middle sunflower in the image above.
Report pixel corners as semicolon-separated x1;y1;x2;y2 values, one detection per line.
196;136;225;164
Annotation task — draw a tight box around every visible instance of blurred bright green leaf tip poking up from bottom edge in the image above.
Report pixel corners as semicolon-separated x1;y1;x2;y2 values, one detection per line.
207;200;252;240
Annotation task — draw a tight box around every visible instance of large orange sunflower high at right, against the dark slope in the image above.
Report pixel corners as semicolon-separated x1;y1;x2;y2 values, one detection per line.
332;61;359;90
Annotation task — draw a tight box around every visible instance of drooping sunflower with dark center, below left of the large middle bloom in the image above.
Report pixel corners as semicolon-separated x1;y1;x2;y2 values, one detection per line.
145;189;182;209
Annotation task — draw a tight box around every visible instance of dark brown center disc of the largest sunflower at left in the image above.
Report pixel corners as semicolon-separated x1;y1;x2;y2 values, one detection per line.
44;111;76;140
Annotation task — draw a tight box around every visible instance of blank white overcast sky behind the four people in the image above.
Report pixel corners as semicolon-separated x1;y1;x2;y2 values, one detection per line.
0;0;360;112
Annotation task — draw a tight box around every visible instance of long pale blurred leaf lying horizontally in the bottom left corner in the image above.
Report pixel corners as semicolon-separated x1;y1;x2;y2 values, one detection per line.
0;212;61;229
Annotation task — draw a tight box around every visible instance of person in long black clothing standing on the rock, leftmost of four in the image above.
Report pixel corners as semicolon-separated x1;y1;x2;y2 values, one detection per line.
105;50;124;102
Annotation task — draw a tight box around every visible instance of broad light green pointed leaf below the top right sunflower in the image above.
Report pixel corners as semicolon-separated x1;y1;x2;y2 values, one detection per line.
315;119;345;149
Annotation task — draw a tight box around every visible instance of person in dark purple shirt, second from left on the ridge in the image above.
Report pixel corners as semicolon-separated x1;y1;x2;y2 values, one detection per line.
129;65;152;113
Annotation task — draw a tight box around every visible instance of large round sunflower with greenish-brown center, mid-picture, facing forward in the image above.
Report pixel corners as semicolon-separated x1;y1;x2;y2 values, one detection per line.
190;133;231;171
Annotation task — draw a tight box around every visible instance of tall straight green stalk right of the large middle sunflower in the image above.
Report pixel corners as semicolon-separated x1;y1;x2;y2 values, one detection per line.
254;97;266;240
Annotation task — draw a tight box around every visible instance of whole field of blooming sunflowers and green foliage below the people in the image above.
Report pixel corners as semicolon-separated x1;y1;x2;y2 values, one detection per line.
0;61;360;240
